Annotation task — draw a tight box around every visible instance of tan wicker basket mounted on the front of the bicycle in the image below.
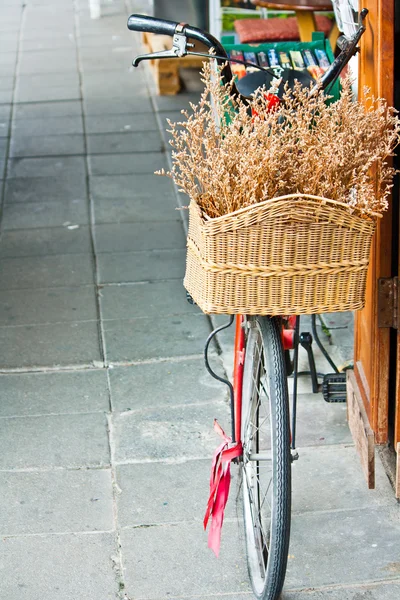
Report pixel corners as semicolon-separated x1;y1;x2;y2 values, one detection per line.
184;194;380;315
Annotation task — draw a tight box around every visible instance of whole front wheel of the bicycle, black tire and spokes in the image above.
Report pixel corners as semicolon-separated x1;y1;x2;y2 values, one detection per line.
242;317;291;600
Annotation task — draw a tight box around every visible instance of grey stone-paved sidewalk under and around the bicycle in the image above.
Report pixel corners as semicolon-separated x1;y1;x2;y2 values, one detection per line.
0;0;400;600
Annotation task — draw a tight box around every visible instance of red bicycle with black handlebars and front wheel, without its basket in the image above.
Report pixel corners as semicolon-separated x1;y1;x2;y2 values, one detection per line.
128;10;368;600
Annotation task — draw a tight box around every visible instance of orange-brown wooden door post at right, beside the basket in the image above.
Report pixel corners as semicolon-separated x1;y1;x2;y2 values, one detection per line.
354;0;394;444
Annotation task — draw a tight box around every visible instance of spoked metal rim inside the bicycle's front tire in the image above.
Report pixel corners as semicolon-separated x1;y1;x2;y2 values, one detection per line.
242;324;274;595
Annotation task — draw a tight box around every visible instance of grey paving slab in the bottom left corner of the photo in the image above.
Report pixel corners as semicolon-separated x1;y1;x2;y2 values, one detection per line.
0;533;118;600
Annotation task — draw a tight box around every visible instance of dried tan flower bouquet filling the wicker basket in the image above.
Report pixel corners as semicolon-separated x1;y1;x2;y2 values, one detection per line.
159;63;400;218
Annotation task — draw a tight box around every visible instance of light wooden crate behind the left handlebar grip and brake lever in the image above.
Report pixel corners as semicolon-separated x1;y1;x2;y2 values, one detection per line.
142;32;207;96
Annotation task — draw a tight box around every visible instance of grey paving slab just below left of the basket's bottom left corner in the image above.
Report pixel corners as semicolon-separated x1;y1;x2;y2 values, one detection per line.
104;315;210;363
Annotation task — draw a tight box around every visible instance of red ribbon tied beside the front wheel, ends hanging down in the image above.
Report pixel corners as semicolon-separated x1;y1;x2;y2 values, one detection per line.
204;419;243;556
